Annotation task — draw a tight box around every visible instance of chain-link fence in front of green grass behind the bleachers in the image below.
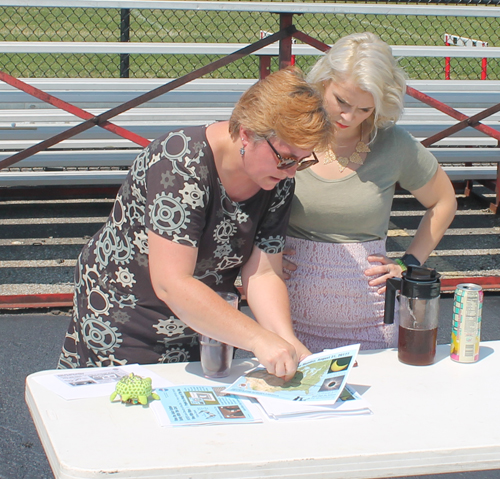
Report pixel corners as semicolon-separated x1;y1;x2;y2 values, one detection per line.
0;0;500;80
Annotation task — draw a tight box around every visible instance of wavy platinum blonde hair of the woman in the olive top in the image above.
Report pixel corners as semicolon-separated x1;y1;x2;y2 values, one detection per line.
307;32;406;137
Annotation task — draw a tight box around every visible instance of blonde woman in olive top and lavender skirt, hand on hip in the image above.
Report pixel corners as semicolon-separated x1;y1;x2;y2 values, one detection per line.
284;33;456;352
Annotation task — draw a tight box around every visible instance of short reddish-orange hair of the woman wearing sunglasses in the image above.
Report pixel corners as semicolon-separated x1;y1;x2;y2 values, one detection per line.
229;67;333;150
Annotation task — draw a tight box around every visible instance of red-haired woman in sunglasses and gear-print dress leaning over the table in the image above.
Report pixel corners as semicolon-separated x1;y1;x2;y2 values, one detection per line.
59;69;331;379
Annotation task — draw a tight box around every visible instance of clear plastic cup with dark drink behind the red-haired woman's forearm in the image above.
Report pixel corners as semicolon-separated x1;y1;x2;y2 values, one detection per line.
200;293;238;378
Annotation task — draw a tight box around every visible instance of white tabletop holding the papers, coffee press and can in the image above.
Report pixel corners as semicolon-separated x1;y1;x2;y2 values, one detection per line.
26;341;500;479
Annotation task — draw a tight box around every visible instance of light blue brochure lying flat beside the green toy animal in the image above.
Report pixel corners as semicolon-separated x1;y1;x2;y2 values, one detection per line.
151;385;262;426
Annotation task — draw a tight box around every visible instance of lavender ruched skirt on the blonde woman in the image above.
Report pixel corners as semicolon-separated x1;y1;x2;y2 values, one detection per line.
286;237;399;352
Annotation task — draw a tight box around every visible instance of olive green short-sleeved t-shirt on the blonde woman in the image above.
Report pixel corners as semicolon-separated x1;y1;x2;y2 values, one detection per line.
287;126;438;243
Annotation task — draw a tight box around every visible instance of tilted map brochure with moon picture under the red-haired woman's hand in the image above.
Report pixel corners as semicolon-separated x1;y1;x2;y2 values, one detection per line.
224;344;359;405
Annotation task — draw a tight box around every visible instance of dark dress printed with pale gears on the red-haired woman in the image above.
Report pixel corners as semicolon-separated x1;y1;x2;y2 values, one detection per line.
58;126;294;368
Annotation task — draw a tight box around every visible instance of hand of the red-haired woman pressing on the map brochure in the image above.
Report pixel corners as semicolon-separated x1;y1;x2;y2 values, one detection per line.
252;329;299;382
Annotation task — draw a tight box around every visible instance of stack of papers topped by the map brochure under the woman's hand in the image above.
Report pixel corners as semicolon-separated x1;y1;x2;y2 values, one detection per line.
224;344;371;419
